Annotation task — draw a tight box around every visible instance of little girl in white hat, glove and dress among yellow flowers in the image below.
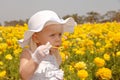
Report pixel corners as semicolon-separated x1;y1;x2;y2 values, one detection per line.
19;10;75;80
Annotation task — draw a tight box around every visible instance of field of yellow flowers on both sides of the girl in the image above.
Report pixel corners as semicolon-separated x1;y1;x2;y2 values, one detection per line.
0;22;120;80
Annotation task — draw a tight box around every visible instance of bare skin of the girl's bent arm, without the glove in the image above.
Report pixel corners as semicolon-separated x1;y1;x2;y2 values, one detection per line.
19;50;38;80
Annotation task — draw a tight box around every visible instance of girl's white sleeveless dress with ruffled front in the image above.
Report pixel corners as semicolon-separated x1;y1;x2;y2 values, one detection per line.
30;49;64;80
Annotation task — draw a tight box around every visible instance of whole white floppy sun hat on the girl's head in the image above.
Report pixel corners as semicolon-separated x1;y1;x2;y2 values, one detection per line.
18;10;76;48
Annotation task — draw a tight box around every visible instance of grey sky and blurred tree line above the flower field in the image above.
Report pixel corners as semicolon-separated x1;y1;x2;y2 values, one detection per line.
0;0;120;26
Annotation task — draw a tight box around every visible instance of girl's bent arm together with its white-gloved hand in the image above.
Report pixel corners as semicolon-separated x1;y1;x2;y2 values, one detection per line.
20;44;50;80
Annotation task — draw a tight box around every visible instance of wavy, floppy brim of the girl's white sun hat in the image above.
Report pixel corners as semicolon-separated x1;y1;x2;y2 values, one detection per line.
18;17;76;48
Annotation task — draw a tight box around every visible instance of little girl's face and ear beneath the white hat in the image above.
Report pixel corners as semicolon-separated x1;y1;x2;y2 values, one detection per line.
35;24;63;47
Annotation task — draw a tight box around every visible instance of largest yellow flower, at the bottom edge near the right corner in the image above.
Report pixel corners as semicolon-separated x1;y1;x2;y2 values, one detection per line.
96;68;112;80
